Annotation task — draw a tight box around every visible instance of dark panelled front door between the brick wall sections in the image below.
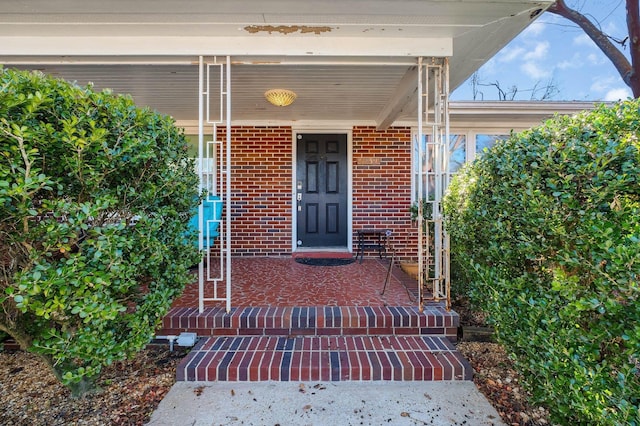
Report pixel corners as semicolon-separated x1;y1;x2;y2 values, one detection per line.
296;134;348;247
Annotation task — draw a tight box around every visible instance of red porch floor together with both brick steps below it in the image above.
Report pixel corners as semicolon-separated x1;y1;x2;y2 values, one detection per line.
159;257;471;381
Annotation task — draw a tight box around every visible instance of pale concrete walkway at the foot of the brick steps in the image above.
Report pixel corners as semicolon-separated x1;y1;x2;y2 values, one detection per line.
148;381;504;426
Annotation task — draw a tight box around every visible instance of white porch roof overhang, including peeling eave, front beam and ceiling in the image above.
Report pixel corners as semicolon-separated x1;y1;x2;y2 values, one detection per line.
0;0;550;127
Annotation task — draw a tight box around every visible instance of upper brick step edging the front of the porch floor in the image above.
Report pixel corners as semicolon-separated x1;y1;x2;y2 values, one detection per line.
157;304;460;341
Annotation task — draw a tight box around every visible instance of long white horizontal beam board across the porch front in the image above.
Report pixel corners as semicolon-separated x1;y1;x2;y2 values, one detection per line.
0;36;453;57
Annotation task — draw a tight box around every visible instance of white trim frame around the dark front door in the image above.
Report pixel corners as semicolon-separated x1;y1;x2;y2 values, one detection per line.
291;128;353;253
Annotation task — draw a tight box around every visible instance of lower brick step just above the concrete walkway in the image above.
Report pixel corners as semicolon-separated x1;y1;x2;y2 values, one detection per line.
177;336;472;382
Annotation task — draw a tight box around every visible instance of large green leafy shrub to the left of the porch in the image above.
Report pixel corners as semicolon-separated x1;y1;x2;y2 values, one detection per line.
0;69;199;394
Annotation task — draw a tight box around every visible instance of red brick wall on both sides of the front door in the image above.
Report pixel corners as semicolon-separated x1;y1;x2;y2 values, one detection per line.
218;126;417;259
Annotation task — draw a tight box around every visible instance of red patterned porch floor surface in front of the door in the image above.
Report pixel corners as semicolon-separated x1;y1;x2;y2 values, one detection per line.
173;257;417;307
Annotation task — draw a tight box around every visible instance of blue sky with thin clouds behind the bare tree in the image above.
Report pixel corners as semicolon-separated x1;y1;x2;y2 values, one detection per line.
451;0;631;101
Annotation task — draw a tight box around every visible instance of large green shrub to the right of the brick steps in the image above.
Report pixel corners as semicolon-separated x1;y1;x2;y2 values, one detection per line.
444;100;640;425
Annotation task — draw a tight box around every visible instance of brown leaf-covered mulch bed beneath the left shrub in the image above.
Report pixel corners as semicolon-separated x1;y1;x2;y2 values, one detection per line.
0;347;185;426
